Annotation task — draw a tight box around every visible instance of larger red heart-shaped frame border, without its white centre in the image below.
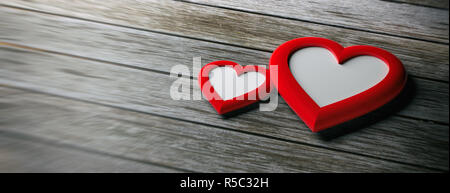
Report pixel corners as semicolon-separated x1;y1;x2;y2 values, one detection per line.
270;37;406;132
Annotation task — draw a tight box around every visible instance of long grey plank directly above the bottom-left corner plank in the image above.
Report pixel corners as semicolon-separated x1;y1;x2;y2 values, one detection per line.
0;86;436;172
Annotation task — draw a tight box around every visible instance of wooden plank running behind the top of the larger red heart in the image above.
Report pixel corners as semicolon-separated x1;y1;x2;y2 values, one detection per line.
1;0;449;82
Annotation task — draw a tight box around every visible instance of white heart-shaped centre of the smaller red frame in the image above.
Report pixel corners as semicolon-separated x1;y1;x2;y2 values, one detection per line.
209;67;266;100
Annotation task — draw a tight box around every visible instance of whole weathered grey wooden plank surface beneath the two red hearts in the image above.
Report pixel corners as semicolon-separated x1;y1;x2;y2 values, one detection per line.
0;0;449;172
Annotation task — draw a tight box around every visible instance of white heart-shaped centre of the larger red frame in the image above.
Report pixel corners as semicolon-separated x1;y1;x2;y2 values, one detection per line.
289;47;389;107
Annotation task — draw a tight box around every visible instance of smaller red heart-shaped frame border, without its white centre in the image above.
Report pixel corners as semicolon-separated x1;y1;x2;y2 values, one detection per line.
198;60;273;114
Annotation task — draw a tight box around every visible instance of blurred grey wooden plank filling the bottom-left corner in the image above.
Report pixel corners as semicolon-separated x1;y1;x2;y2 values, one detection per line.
0;132;180;173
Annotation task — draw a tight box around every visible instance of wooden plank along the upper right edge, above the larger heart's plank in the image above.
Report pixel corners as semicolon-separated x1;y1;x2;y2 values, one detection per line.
182;0;449;43
